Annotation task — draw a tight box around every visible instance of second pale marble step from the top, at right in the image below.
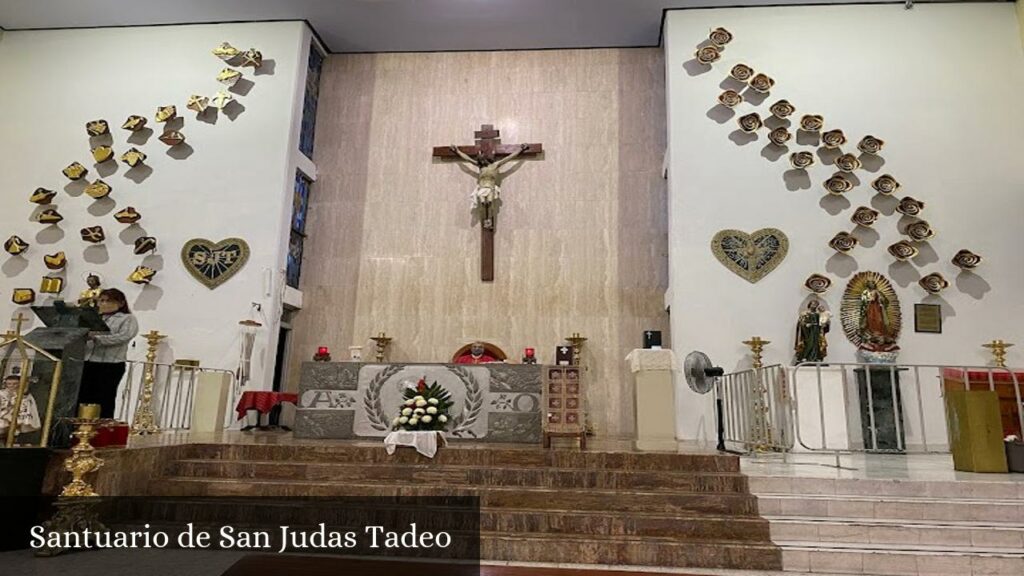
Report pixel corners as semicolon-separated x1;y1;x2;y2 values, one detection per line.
757;493;1024;524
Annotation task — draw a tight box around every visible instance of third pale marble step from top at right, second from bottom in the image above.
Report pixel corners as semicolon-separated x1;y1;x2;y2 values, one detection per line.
766;517;1024;550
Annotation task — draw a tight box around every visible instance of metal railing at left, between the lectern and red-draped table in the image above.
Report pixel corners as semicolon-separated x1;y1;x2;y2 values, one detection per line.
114;361;240;430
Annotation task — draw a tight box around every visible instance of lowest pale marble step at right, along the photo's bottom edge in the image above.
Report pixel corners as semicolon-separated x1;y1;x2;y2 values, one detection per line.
778;542;1024;576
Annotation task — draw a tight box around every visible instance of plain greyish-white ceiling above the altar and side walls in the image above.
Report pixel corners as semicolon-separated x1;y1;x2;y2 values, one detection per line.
0;0;929;52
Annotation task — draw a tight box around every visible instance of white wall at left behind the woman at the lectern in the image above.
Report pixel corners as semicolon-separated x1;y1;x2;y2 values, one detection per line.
0;23;309;388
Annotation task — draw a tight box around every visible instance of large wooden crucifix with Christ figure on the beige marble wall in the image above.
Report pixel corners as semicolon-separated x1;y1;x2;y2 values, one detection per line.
433;124;544;282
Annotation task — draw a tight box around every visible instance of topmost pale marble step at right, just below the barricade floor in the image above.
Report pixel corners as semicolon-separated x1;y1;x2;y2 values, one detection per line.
750;476;1024;500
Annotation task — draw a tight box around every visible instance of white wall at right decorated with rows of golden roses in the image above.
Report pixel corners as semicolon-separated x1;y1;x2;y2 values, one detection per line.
665;3;1024;439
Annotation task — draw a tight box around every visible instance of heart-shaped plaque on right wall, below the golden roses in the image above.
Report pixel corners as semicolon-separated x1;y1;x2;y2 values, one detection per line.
711;228;790;283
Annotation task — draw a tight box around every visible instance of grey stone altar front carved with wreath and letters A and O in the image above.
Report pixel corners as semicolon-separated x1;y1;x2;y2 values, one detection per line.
295;362;542;443
